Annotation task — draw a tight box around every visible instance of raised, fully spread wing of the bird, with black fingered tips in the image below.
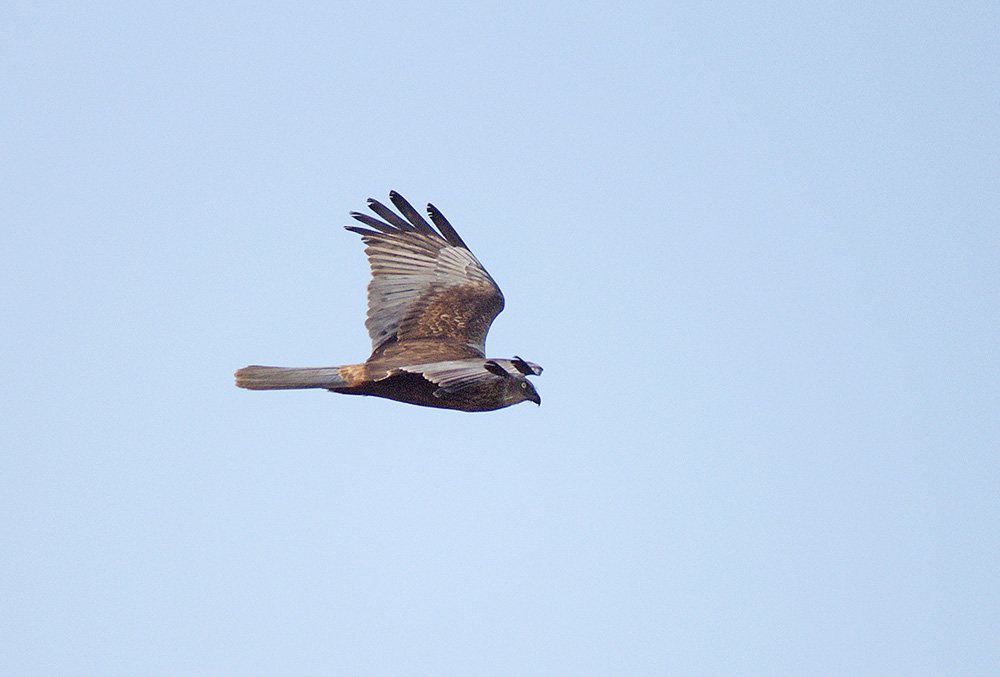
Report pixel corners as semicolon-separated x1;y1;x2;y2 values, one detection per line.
346;191;503;355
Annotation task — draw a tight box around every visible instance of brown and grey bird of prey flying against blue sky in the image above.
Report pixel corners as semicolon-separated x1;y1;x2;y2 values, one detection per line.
236;191;542;411
